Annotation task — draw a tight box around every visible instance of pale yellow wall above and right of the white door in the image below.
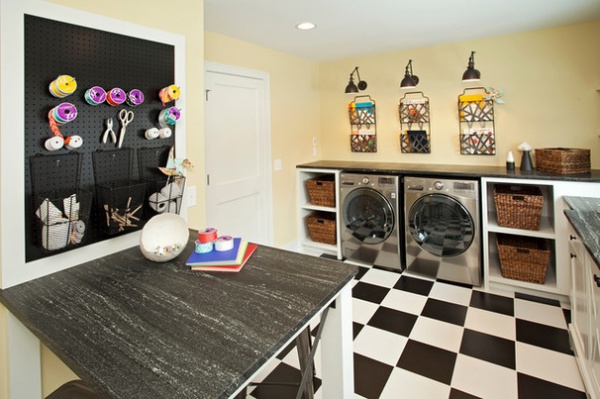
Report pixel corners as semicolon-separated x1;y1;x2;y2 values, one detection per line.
204;32;320;246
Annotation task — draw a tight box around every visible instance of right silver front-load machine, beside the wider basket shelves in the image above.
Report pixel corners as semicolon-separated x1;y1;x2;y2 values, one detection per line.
404;177;482;286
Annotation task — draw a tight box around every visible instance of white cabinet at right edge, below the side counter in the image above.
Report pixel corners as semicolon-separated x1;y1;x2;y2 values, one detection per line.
569;226;600;398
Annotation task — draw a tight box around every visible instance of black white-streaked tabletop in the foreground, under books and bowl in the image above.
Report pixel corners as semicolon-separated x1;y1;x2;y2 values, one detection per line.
0;232;357;399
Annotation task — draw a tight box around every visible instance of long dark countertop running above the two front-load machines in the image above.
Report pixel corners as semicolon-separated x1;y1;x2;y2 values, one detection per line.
297;160;600;182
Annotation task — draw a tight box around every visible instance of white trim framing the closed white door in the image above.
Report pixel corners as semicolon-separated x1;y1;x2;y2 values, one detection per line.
204;61;273;245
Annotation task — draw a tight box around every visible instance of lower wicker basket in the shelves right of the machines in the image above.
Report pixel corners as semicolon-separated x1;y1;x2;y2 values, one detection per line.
496;234;550;284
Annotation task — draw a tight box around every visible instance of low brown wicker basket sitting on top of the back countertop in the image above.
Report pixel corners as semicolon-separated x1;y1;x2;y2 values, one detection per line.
535;148;591;175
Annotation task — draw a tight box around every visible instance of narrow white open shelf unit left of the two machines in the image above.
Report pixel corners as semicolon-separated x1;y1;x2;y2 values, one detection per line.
296;168;342;259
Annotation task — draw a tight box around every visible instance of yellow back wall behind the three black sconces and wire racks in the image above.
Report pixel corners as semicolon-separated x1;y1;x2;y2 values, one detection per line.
320;21;600;169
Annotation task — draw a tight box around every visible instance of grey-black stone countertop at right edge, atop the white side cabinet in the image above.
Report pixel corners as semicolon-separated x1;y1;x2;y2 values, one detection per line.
563;196;600;268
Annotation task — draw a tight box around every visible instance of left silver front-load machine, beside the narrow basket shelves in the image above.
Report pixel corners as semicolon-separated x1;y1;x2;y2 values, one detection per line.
340;173;401;270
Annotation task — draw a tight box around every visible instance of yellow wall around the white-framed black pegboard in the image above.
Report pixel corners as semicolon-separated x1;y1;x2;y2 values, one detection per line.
0;0;204;399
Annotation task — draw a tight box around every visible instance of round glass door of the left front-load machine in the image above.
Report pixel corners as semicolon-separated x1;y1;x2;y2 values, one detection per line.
343;188;394;244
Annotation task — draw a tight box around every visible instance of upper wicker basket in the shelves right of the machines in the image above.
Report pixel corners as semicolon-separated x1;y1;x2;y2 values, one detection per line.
494;184;544;230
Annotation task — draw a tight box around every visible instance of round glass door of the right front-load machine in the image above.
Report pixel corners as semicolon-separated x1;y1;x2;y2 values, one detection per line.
408;194;475;256
